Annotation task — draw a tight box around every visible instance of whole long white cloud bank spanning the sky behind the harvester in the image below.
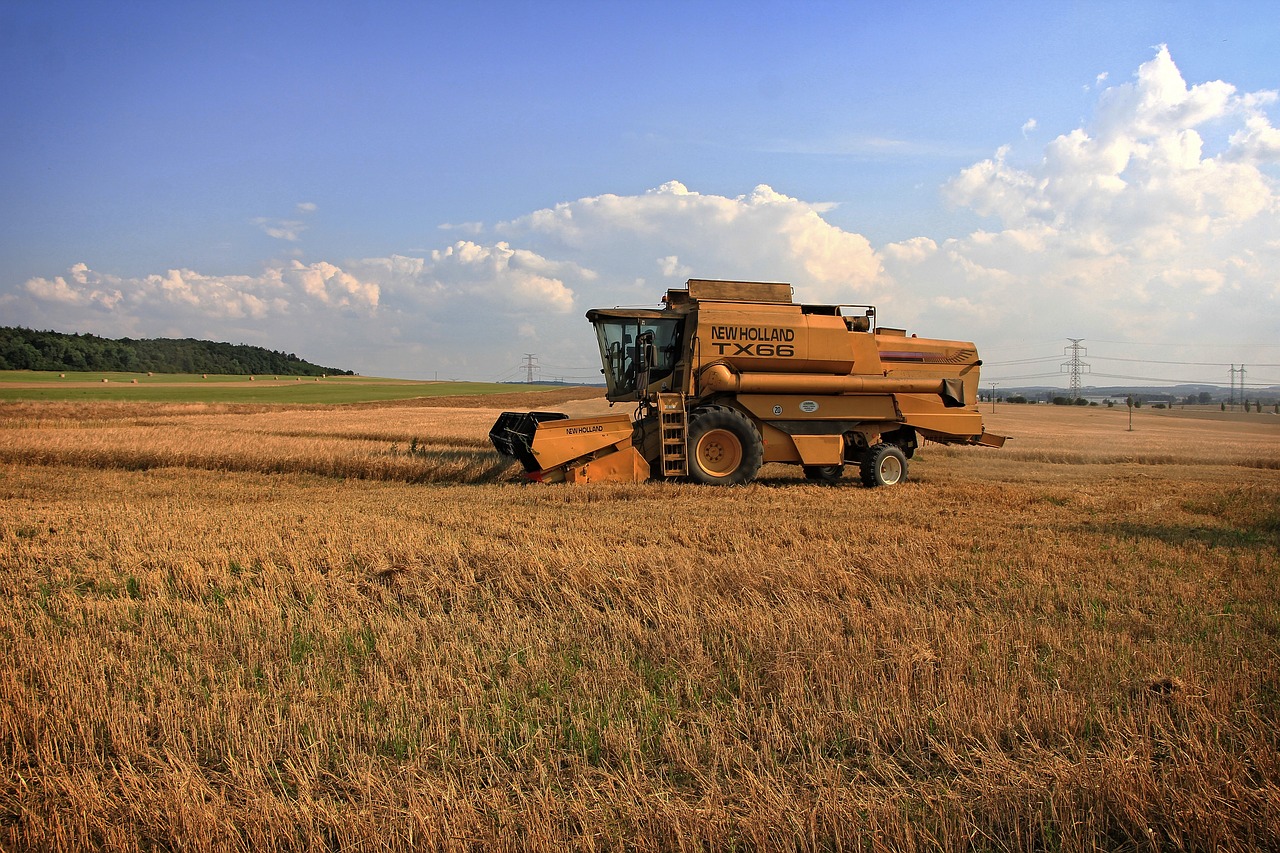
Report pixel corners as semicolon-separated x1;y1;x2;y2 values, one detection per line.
0;47;1280;379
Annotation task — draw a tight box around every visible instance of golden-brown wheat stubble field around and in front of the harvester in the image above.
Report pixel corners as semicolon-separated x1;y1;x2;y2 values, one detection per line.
0;393;1280;850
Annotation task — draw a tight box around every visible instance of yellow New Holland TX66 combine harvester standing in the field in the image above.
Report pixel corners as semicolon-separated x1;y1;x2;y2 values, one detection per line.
489;279;1005;485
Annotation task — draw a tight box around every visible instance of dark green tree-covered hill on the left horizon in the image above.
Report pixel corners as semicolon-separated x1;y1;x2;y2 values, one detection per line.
0;327;352;377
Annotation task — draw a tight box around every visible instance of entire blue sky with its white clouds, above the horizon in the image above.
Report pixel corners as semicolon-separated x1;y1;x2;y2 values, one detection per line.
0;1;1280;384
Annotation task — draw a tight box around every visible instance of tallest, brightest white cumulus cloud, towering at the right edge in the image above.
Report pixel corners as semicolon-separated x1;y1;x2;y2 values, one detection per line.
931;47;1280;350
